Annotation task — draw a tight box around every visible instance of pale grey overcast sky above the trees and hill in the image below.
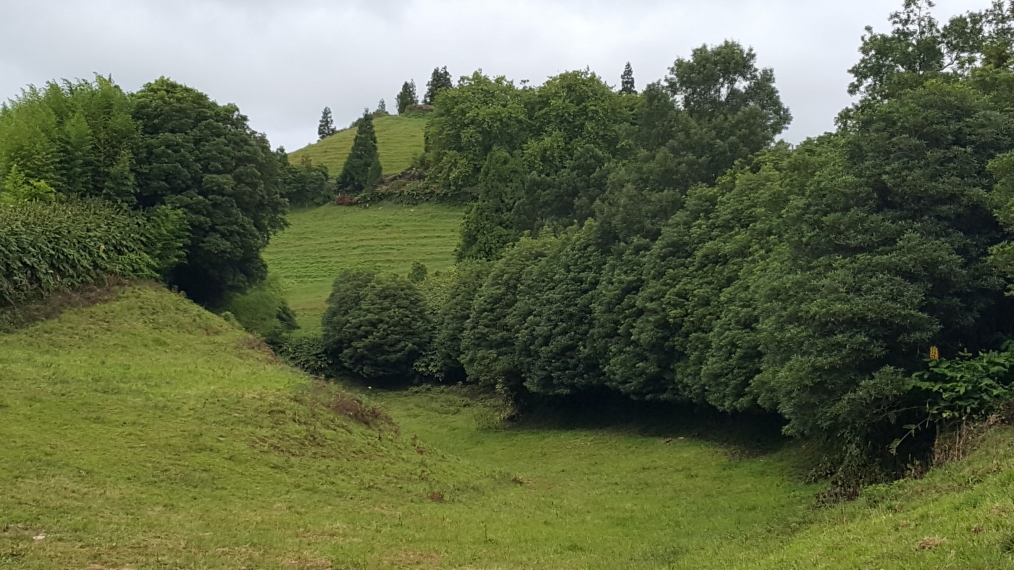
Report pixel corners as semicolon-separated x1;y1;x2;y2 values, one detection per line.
0;0;989;150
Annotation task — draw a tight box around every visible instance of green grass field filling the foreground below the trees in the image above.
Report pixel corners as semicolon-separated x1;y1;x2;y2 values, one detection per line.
0;286;1014;570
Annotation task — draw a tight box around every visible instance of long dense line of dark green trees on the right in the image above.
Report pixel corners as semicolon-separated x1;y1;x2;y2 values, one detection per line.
310;0;1014;478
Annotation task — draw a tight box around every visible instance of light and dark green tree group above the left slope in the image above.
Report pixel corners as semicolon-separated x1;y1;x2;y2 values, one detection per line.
0;76;329;306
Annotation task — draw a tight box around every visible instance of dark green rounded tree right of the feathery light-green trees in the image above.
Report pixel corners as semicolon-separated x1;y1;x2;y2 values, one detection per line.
133;77;286;304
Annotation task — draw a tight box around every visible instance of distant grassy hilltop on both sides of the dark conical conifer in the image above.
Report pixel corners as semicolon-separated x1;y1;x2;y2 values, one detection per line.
289;115;426;176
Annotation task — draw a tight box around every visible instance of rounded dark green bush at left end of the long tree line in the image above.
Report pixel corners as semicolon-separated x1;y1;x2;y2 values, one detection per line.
321;272;431;380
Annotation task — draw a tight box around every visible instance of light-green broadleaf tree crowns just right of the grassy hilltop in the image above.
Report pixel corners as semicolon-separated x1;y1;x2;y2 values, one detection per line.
427;72;632;260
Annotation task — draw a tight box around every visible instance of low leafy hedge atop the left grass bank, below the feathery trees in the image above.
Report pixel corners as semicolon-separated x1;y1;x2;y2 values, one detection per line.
0;202;187;307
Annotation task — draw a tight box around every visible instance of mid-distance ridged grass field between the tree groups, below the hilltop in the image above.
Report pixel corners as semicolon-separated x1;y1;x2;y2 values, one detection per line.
264;204;463;329
